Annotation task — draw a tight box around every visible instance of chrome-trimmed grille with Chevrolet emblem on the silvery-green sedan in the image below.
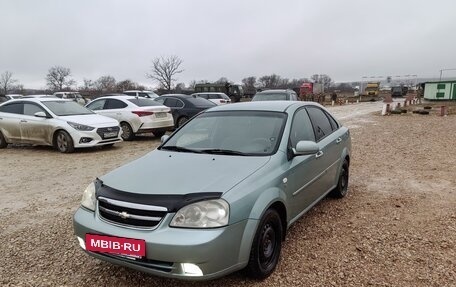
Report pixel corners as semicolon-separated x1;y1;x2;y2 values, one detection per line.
98;196;168;228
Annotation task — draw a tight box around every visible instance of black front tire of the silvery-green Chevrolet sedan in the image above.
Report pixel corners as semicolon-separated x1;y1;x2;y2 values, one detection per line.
246;209;283;279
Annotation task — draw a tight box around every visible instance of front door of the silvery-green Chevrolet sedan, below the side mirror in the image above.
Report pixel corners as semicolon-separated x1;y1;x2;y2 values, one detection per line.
285;108;325;218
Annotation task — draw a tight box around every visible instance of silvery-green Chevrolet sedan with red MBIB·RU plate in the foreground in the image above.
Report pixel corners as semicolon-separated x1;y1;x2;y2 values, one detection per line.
74;101;351;280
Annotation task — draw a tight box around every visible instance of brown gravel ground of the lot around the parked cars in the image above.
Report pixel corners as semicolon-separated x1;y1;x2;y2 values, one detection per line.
0;103;456;286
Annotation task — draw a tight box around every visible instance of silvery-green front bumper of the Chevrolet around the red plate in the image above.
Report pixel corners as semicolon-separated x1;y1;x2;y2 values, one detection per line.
73;208;258;280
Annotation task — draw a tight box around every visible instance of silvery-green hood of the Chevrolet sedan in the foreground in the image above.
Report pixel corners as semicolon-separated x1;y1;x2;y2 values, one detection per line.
100;150;270;195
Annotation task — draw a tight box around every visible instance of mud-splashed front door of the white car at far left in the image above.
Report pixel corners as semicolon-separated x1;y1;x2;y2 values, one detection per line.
20;102;53;144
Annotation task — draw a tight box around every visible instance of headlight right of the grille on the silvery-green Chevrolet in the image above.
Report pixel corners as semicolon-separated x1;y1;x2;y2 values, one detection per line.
170;199;230;228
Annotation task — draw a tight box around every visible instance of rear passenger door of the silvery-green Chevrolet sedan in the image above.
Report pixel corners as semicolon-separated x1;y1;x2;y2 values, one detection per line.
306;106;341;193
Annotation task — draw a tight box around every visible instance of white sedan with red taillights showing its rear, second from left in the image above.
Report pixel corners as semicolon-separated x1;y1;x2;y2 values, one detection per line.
86;95;174;141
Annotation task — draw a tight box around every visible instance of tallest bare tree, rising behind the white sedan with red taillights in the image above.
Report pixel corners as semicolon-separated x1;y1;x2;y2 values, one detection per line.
146;56;184;91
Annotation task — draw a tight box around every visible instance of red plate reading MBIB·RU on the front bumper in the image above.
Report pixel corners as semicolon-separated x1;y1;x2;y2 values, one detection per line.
85;234;146;258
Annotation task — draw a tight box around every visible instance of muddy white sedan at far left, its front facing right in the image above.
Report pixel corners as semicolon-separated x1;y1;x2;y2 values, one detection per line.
0;97;122;153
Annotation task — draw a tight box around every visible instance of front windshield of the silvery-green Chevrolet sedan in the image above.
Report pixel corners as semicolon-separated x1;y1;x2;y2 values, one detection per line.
160;111;286;156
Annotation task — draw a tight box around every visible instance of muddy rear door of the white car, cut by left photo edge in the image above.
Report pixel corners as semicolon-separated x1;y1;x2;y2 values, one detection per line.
0;102;24;143
